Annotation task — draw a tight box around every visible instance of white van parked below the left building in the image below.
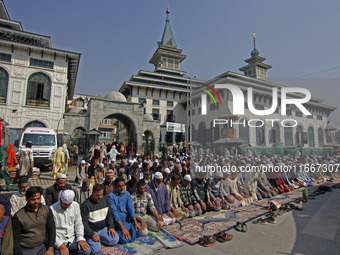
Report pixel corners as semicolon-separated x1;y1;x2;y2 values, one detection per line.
19;127;57;166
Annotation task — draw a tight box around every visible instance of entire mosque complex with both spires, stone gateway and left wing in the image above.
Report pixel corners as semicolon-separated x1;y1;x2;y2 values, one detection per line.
0;0;338;154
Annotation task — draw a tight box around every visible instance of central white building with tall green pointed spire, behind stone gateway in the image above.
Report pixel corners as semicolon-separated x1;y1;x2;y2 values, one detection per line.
119;6;202;145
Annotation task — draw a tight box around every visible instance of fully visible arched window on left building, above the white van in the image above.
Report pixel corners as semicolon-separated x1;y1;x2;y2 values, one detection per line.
26;72;52;107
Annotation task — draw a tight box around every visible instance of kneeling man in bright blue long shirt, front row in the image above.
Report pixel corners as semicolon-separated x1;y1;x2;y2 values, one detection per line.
108;177;147;244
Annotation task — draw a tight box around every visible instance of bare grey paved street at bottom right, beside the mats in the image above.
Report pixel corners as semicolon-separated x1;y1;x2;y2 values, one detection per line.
161;187;340;255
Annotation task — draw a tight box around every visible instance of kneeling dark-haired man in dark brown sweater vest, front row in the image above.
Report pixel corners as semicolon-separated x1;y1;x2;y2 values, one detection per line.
12;187;56;255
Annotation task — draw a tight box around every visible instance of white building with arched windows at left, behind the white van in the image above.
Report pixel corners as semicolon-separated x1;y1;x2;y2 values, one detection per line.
0;1;80;143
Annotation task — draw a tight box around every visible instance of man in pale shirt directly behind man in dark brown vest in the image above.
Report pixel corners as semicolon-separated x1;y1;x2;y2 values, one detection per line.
9;177;45;216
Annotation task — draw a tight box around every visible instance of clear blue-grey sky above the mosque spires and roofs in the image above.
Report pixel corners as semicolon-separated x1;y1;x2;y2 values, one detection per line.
4;0;340;128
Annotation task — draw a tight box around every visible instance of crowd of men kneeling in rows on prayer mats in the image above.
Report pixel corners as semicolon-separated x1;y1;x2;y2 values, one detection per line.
0;145;340;254
